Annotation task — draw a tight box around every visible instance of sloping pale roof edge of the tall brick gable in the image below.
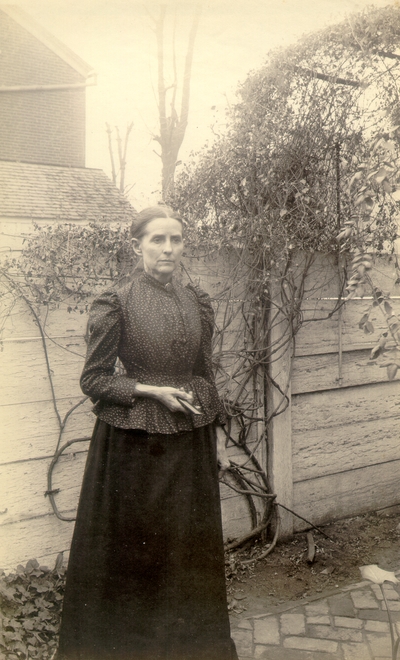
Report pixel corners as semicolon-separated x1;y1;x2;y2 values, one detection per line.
0;5;94;78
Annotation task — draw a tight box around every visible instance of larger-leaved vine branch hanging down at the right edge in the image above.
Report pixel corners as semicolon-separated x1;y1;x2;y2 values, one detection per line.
337;133;400;380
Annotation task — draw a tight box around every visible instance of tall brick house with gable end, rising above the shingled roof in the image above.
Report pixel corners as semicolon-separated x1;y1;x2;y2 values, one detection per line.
0;5;94;167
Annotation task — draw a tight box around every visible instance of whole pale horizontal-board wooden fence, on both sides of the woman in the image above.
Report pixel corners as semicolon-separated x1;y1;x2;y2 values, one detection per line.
0;248;400;569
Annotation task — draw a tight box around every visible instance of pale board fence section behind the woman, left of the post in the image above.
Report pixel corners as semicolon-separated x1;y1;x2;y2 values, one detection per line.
0;250;265;570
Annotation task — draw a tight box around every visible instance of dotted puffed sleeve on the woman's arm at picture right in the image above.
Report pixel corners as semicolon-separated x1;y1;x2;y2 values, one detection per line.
187;284;226;424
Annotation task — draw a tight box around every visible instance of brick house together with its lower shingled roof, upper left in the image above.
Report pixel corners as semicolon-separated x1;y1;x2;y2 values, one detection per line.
0;5;134;231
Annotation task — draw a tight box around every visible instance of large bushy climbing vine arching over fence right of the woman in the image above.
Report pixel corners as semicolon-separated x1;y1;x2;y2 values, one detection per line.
171;1;400;536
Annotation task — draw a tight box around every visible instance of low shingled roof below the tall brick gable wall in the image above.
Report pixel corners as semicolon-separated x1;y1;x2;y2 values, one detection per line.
0;160;136;222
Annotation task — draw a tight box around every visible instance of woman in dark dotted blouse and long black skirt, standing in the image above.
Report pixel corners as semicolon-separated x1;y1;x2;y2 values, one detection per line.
57;207;237;660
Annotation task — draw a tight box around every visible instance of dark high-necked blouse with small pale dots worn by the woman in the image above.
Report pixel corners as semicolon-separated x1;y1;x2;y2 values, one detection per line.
81;273;225;433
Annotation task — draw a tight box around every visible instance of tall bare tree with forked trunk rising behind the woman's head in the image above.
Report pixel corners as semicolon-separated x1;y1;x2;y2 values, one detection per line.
151;5;201;199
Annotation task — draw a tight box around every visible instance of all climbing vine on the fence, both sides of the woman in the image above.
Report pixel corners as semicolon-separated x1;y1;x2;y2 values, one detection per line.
1;7;400;549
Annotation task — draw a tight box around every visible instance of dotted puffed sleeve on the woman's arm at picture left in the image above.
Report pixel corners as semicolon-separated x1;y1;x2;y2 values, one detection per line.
80;291;135;406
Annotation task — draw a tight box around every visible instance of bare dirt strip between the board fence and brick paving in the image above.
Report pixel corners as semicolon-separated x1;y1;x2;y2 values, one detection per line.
226;506;400;616
